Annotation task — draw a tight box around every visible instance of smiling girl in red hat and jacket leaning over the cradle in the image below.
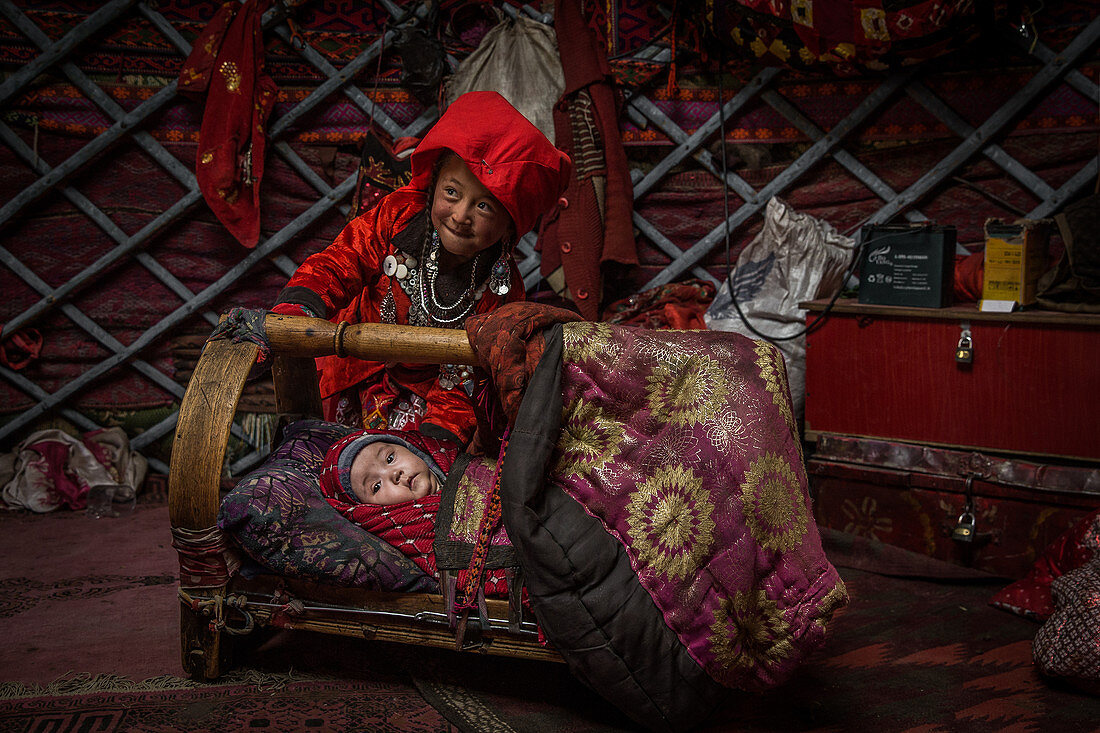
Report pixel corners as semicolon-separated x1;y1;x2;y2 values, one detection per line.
273;91;572;446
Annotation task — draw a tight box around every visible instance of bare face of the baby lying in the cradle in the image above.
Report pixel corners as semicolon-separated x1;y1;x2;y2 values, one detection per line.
351;440;439;505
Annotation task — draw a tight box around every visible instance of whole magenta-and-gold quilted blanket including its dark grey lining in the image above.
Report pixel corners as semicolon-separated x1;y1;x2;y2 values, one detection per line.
486;310;847;730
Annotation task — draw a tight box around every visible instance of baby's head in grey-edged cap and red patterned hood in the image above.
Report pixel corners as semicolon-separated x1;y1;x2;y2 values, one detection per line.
321;430;457;506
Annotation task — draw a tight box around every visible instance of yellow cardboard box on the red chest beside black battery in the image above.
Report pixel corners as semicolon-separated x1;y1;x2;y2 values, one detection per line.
981;219;1051;306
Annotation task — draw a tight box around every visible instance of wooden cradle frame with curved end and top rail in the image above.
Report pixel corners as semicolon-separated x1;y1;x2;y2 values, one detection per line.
168;315;562;679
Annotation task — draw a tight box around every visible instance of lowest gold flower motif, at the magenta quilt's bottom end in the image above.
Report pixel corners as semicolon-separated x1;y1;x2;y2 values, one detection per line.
708;590;793;679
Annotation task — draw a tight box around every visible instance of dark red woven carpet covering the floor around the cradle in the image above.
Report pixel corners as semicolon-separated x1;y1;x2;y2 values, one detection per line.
0;503;1100;733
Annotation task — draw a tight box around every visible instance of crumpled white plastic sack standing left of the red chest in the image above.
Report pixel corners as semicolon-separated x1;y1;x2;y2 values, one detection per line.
703;198;856;424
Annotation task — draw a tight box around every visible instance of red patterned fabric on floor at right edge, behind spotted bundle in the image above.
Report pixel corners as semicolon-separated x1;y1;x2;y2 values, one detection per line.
990;510;1100;621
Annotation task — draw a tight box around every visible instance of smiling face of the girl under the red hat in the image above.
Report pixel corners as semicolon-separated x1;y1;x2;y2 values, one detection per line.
431;153;515;262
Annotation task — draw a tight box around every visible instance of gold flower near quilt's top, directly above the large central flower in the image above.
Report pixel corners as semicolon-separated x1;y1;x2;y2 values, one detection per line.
646;355;729;426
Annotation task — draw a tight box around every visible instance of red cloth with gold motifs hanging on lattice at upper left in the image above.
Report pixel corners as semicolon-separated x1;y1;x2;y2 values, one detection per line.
179;0;278;249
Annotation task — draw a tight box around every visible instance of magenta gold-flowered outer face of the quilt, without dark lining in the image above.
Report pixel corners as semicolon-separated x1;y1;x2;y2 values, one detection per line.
550;322;848;690
